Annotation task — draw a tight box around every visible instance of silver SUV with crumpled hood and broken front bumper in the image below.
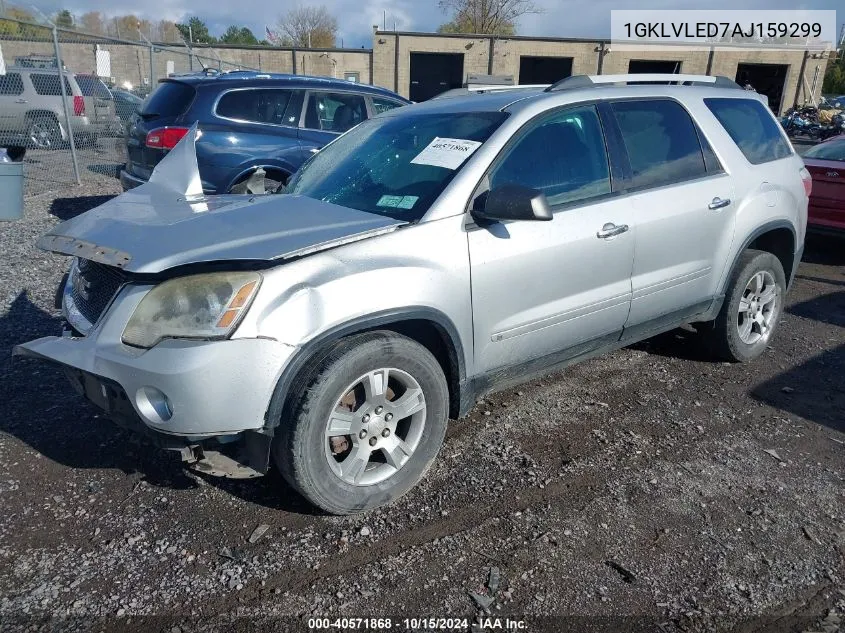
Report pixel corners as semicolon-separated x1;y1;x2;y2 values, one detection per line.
15;75;810;514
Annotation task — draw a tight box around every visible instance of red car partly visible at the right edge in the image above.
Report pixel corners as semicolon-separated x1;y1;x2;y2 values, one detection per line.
804;135;845;234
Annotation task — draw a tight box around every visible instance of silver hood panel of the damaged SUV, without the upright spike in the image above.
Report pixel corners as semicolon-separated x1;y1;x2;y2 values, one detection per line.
38;182;406;273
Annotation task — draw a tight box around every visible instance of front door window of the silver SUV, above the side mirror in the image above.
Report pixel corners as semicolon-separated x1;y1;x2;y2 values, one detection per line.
489;106;610;206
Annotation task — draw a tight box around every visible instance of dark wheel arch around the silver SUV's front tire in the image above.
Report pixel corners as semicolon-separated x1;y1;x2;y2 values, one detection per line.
265;306;472;429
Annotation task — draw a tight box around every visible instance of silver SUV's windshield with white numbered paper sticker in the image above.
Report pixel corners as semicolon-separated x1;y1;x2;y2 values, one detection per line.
286;112;507;222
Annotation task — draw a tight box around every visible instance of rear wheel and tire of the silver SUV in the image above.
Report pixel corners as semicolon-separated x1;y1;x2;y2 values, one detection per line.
702;250;786;363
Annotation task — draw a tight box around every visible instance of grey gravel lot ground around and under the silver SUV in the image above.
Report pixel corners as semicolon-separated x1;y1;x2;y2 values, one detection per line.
0;184;845;633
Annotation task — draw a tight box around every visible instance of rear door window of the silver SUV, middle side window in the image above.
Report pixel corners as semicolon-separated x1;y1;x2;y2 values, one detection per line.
613;99;707;188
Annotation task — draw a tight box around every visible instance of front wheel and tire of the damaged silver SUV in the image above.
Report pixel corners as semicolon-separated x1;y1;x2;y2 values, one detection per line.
273;331;449;514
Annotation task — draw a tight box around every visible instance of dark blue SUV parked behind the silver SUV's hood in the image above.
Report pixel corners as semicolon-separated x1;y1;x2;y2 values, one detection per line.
120;71;410;194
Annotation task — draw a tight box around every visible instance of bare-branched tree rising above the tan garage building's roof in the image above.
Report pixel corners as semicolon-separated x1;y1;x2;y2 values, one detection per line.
438;0;543;35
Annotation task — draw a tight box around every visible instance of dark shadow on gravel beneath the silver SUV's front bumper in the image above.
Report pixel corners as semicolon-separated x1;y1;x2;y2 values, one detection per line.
0;291;314;514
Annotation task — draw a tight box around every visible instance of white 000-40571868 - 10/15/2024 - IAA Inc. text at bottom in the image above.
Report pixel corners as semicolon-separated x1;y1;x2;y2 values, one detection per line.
308;617;528;631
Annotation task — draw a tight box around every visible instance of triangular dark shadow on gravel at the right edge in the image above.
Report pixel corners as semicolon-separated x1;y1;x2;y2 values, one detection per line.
751;345;845;432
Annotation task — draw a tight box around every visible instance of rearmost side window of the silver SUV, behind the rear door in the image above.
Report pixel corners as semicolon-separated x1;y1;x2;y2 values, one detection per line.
704;98;792;165
